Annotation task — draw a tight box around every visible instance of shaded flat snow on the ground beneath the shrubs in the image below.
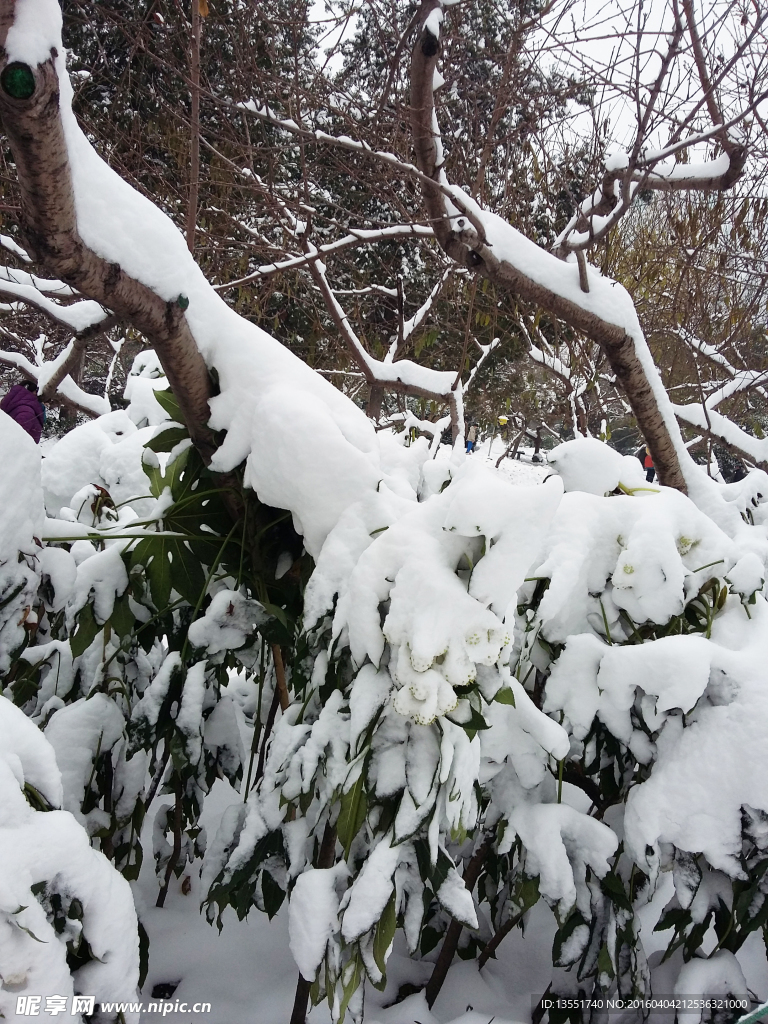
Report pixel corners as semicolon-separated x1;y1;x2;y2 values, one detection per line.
134;780;768;1024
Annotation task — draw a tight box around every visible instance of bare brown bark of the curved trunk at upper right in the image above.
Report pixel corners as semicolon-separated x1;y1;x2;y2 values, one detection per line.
411;0;687;494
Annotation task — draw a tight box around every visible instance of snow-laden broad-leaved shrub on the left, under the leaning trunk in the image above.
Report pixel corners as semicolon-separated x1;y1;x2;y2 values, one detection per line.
0;376;299;905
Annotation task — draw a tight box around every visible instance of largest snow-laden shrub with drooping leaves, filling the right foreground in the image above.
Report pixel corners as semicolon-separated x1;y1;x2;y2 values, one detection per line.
196;442;768;1019
